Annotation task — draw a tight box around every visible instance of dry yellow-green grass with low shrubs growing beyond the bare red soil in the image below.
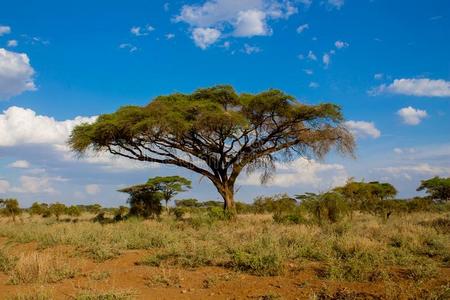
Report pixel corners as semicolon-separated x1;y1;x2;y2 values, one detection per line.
0;213;450;282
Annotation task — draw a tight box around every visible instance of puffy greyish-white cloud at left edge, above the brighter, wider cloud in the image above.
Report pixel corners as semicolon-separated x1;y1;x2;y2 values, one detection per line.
0;48;36;100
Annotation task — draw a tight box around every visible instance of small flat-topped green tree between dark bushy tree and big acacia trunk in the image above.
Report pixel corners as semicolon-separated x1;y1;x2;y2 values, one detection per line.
147;176;191;210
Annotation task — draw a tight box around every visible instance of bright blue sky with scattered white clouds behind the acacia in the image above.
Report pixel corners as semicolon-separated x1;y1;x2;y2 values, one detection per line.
0;0;450;206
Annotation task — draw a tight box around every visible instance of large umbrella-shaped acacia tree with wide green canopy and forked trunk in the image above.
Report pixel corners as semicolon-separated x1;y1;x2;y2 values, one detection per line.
68;86;354;210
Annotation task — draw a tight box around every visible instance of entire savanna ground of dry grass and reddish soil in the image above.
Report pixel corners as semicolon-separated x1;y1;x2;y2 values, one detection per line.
0;210;450;299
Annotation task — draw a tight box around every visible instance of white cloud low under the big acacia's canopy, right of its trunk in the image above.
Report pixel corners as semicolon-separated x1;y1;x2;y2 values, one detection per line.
240;158;348;189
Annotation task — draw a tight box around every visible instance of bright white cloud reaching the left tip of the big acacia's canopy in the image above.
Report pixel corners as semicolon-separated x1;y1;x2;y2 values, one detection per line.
0;106;96;147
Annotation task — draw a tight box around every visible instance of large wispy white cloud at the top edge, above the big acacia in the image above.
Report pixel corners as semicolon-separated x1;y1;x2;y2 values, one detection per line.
175;0;304;49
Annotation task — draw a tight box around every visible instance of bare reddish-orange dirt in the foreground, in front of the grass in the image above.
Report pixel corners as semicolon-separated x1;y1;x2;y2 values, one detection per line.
0;239;450;299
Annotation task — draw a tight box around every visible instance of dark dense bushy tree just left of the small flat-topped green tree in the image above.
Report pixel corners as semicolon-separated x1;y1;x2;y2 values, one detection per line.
119;184;163;218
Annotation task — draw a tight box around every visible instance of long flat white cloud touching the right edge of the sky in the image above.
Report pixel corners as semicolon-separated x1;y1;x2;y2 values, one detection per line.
369;78;450;97
